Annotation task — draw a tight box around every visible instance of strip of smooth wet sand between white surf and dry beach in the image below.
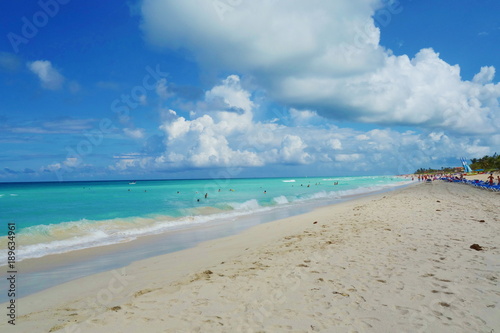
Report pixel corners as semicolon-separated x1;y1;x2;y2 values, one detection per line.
0;183;412;303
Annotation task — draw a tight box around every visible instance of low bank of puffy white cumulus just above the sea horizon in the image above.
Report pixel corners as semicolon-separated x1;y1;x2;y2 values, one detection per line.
107;75;493;174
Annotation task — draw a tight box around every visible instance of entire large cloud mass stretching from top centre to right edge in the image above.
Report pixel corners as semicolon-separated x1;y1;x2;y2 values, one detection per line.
142;0;500;134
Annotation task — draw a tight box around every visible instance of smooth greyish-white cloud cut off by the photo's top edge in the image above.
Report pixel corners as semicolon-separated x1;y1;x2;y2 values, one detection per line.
142;0;379;73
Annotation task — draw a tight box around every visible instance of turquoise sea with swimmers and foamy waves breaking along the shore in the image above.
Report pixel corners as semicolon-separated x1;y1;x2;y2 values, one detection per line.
0;176;407;260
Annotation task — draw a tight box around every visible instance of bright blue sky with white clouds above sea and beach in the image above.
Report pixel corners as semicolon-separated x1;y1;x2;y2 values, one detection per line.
0;0;500;182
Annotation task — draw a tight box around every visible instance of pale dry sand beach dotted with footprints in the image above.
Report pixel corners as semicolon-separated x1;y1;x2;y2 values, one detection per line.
0;181;500;333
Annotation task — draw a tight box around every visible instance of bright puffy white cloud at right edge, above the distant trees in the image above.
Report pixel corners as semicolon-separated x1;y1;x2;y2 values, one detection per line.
280;49;500;133
